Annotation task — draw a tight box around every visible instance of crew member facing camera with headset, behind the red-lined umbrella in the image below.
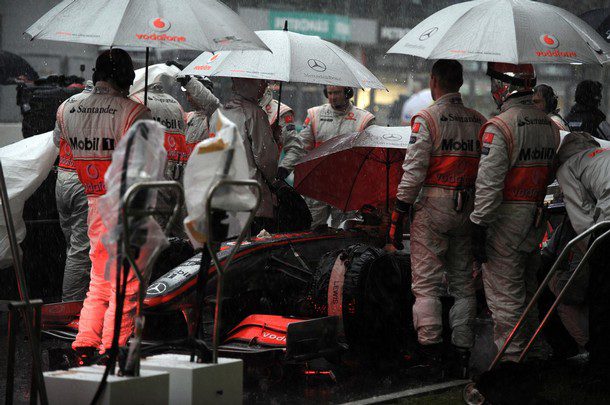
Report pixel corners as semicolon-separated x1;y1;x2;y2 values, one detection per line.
284;86;375;228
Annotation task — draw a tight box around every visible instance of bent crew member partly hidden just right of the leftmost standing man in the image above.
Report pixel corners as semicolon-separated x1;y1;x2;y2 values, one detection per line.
131;82;186;180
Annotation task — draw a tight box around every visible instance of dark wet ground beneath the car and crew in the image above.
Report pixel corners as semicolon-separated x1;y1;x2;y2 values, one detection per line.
0;315;610;405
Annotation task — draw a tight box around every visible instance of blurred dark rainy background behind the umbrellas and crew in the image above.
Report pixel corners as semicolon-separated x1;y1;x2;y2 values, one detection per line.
0;0;610;137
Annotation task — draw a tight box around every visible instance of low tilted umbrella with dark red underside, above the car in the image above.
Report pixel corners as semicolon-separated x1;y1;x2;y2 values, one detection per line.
294;125;411;211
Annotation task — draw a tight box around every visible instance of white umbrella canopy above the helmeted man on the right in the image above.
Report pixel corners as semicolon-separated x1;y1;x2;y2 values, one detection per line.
388;0;610;64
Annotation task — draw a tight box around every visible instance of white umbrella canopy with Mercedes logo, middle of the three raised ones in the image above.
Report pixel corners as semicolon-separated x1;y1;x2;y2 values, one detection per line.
182;30;385;89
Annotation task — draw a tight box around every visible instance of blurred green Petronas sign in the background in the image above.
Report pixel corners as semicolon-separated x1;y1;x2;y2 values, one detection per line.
269;10;351;41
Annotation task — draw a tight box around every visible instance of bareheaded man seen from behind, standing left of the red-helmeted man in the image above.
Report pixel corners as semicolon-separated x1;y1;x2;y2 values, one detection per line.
390;59;485;377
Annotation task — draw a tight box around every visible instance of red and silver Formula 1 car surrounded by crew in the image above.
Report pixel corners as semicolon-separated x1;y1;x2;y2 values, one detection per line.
42;230;410;363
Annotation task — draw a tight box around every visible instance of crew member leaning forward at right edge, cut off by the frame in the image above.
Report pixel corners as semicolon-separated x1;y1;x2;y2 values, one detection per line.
557;132;610;370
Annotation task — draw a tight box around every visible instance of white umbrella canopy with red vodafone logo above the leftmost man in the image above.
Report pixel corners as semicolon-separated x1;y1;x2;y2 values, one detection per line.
26;0;266;52
